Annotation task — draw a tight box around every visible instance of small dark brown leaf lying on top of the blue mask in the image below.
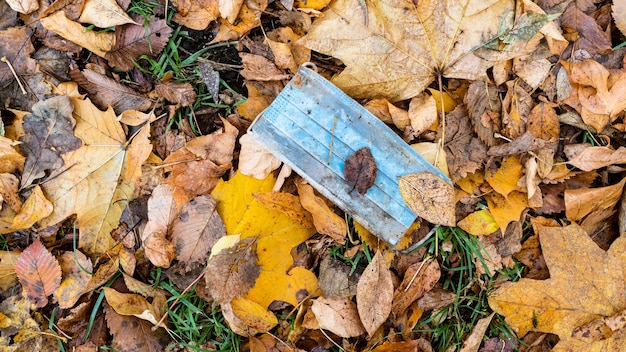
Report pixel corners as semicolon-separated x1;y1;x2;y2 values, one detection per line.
343;147;377;194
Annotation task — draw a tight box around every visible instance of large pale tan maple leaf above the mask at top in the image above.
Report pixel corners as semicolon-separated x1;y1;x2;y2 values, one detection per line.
303;0;542;101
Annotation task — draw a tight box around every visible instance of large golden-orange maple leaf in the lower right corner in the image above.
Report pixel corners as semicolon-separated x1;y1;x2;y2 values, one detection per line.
489;225;626;352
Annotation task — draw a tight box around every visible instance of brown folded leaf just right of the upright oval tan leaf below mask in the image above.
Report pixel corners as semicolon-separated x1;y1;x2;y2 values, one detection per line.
392;259;441;317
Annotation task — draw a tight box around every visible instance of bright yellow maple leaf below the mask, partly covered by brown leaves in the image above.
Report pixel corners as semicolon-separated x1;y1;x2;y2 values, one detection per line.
212;173;320;308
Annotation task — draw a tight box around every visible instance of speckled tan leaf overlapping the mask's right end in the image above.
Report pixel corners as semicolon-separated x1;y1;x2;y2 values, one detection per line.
398;172;456;226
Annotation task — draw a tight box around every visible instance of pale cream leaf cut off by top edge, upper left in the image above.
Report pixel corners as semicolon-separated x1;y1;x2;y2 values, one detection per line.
78;0;137;28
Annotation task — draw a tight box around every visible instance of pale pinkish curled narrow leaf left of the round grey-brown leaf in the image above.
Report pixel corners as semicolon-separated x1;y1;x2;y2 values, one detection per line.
140;184;182;268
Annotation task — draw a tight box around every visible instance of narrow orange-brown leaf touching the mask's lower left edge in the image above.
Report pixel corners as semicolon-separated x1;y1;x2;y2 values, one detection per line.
298;184;348;243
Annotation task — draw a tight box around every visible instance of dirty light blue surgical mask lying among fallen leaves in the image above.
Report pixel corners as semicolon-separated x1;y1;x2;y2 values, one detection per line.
249;64;451;247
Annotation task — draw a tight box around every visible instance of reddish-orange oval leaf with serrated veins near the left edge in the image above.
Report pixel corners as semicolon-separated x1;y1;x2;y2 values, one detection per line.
15;239;61;308
